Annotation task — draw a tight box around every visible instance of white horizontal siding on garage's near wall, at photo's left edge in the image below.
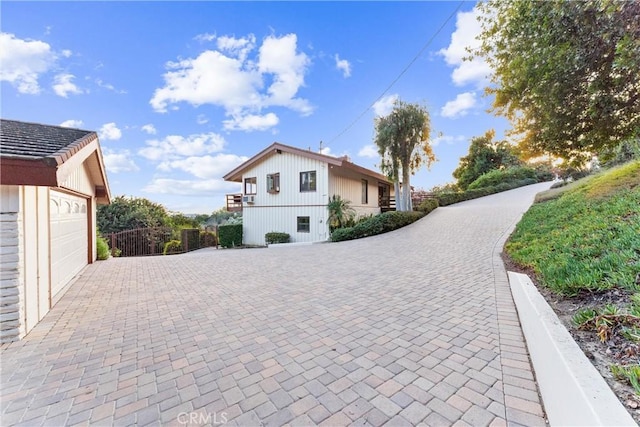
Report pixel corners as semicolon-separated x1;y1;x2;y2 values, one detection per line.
0;185;25;343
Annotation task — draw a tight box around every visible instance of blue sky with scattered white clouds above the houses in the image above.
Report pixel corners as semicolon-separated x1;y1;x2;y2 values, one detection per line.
0;2;506;213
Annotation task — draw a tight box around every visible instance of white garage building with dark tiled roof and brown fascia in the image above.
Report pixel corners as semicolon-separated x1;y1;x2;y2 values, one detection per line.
0;120;110;342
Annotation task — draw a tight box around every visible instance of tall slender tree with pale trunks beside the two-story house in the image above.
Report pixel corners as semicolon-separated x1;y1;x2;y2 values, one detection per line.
374;99;436;211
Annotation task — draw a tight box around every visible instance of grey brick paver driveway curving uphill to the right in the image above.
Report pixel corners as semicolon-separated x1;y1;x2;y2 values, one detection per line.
0;184;548;426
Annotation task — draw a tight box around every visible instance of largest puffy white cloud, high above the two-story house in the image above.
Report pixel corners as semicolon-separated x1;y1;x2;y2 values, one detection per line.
149;34;313;130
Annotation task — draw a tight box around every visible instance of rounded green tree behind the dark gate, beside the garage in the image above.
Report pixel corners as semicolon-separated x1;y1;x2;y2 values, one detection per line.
97;196;171;234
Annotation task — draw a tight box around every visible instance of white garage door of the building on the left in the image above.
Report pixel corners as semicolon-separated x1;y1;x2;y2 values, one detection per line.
50;191;89;297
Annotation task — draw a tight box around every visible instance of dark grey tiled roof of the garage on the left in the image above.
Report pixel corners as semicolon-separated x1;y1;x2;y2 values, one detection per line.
0;119;96;159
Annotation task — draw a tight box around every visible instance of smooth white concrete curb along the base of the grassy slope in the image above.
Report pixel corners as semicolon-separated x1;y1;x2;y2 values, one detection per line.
508;271;637;426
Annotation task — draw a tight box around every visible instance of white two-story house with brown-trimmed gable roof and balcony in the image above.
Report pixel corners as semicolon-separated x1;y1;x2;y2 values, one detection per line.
224;142;393;245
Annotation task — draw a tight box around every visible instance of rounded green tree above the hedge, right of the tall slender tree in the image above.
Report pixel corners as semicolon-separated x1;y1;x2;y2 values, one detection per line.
453;130;522;190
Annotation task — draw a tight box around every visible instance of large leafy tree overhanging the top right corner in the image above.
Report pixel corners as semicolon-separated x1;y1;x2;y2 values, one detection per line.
471;0;640;165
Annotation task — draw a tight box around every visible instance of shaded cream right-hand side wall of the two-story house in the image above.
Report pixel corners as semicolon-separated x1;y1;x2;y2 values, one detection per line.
329;171;380;216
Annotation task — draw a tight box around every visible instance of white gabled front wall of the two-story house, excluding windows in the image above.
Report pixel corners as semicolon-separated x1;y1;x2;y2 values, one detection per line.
242;153;329;245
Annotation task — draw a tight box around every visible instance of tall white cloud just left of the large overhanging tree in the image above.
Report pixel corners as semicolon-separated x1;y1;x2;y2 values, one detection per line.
438;8;491;87
